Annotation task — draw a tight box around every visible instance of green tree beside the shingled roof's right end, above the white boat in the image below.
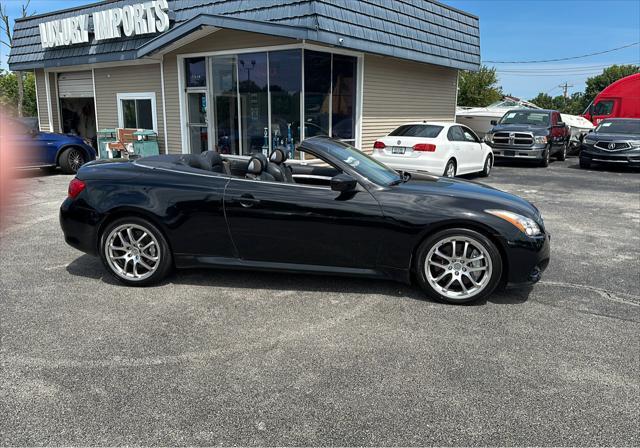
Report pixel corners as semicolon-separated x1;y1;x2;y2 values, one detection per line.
458;65;502;107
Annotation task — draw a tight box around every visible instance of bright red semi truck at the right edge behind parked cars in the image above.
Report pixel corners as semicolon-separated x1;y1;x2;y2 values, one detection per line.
582;73;640;126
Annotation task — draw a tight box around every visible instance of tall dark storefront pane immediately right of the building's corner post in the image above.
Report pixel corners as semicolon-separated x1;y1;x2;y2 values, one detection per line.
304;50;331;138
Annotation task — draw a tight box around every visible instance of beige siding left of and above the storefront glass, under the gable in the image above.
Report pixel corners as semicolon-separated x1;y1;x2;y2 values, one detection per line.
164;30;296;153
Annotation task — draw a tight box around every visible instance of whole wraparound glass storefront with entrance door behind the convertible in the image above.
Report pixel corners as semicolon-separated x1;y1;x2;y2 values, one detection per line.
184;49;357;157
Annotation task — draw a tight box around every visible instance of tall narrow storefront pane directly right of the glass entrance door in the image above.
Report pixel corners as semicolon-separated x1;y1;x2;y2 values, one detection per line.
211;56;240;154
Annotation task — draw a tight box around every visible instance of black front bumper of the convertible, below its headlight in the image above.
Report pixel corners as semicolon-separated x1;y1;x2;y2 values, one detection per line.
506;233;551;288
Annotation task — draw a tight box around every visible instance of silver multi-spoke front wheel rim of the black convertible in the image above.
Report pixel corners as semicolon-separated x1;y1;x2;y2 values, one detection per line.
424;236;493;300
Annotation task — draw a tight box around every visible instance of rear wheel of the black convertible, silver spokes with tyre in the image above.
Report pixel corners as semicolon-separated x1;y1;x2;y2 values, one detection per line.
100;217;172;286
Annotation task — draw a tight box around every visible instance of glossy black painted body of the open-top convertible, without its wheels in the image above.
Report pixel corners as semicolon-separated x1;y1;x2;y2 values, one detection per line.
60;137;549;284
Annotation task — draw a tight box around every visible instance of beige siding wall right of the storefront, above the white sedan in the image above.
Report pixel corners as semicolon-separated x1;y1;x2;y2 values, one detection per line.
362;55;458;151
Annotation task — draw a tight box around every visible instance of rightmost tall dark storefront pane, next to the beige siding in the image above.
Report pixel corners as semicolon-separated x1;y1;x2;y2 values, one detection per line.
331;54;357;144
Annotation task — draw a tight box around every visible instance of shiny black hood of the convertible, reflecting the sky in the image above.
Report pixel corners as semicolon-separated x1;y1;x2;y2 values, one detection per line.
394;171;541;222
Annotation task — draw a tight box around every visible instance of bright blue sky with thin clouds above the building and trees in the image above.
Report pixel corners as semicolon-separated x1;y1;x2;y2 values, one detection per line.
0;0;640;99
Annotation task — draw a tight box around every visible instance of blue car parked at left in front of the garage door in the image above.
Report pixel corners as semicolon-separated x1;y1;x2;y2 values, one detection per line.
13;119;96;174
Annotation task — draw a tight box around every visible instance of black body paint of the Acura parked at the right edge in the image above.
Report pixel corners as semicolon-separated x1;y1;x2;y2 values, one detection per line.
580;119;640;168
